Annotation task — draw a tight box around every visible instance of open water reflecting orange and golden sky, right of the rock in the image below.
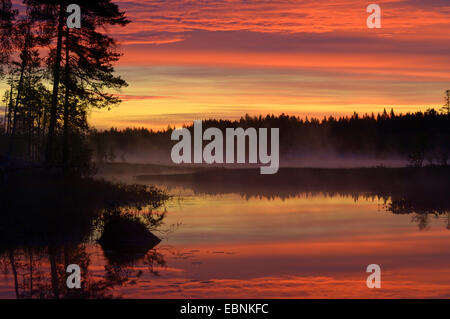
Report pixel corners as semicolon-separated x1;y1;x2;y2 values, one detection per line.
142;195;450;298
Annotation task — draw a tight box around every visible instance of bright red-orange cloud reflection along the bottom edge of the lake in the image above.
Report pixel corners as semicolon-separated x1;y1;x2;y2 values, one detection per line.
114;272;449;298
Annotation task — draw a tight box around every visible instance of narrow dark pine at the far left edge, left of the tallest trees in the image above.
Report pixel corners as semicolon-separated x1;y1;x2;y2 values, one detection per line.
3;2;54;159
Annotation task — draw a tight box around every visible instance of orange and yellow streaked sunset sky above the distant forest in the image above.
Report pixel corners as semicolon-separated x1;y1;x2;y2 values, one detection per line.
5;0;450;129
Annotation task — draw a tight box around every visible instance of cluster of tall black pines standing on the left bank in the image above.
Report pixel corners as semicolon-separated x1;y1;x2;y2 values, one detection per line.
0;0;130;172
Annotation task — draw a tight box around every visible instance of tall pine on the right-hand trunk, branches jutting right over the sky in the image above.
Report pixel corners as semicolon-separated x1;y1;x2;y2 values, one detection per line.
62;1;129;169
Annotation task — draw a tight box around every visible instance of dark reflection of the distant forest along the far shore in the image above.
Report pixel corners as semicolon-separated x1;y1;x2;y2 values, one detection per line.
138;167;450;229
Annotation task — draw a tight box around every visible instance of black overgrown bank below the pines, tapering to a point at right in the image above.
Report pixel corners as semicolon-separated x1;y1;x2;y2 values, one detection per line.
0;172;168;250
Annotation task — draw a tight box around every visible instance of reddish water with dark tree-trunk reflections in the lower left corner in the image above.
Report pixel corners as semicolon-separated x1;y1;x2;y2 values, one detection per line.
0;212;166;299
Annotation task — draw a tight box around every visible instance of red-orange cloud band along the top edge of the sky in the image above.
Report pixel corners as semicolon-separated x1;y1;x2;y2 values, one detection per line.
111;0;450;43
